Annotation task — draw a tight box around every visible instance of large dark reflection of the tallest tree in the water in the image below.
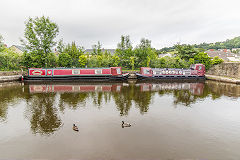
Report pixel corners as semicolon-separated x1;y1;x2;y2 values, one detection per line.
24;93;62;135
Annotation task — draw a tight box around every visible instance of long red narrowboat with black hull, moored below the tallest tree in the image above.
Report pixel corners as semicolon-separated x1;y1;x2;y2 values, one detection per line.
23;67;129;81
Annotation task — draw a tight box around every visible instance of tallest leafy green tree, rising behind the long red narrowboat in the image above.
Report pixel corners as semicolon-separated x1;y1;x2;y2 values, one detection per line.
21;16;59;67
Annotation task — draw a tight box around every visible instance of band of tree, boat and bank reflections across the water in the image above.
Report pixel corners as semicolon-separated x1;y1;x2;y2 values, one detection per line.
0;81;240;135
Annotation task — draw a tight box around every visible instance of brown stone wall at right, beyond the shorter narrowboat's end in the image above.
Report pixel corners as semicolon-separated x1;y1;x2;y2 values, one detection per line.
207;62;240;78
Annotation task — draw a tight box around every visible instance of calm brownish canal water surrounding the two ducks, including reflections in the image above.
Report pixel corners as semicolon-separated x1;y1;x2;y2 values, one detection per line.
0;81;240;160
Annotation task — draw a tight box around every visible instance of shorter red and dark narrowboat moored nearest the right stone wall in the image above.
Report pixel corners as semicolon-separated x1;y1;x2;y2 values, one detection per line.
136;64;206;80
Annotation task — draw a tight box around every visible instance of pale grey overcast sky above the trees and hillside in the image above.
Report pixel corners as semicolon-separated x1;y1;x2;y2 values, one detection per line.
0;0;240;49
